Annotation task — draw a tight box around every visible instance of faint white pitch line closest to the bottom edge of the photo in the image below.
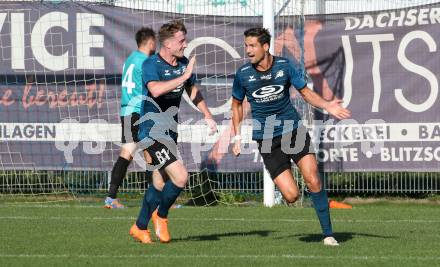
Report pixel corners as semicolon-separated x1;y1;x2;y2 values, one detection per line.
0;253;440;261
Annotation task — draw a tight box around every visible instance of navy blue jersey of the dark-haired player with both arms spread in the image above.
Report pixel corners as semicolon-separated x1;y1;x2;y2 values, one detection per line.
232;57;307;140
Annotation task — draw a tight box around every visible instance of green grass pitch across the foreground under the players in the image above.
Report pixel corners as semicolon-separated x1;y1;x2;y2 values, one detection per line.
0;202;440;267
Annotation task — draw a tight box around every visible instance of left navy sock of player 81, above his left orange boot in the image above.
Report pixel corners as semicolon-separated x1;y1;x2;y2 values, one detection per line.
136;184;162;230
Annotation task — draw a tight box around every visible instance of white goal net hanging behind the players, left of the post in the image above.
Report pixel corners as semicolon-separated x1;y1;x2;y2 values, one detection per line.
0;0;310;205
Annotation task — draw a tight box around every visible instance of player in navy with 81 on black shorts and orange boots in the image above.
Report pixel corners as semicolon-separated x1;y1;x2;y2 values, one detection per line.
130;21;217;243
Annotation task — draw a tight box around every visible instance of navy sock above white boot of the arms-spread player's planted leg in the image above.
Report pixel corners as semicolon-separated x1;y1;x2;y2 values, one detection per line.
310;189;333;236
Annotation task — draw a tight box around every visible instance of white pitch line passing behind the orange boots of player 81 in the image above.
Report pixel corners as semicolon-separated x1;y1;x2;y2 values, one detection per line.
0;216;440;223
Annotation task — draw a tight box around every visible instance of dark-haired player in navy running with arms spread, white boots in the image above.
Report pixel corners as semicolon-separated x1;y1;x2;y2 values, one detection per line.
232;28;351;246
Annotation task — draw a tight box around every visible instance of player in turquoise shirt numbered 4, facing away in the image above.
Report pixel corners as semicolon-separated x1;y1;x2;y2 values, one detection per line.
104;27;156;209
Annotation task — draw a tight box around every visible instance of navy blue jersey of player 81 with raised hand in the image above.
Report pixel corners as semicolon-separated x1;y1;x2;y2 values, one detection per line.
139;54;195;140
